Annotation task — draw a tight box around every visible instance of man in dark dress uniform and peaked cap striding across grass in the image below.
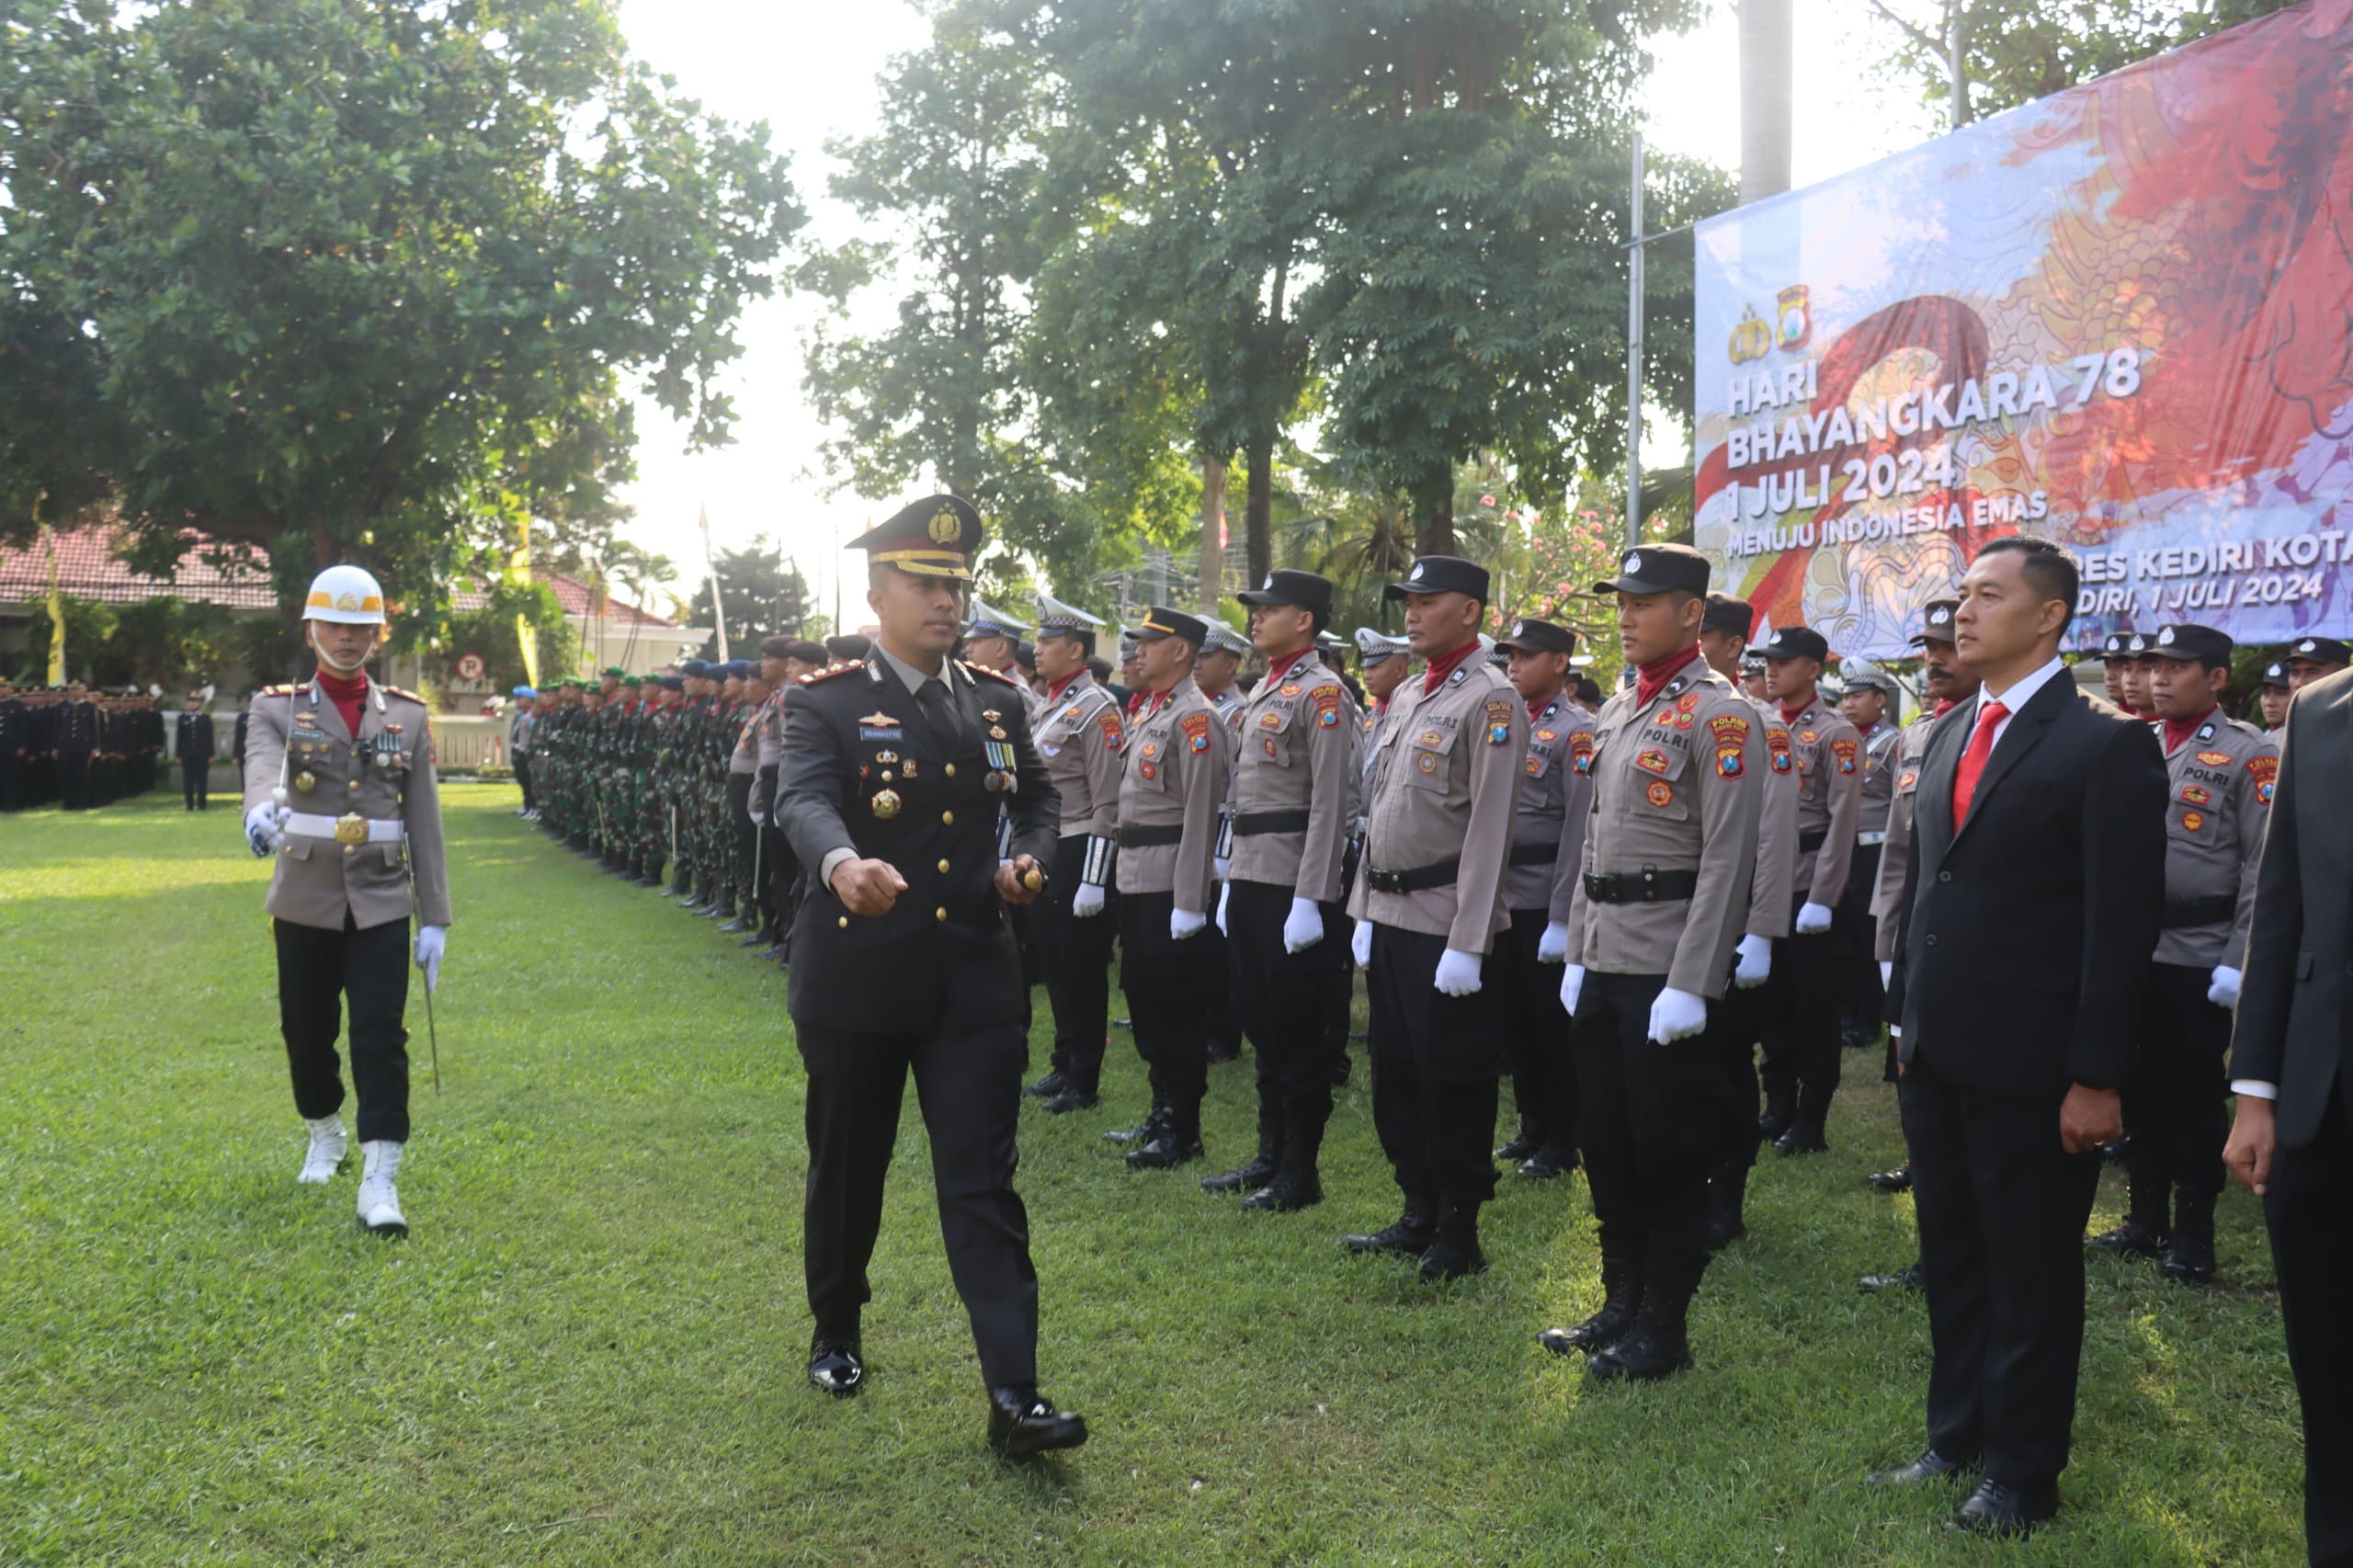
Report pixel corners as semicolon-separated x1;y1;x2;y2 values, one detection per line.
779;494;1087;1458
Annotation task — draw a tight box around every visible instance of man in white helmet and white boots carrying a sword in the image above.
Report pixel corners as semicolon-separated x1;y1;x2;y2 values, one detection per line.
244;565;449;1236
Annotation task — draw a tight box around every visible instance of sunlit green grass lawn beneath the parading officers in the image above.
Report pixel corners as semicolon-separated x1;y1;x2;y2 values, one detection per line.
0;784;2302;1565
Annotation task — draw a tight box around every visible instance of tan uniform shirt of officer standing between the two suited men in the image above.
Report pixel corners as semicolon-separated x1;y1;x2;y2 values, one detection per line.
2153;709;2280;970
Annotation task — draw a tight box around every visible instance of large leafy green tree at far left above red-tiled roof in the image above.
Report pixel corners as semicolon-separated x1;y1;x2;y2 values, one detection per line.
0;0;802;608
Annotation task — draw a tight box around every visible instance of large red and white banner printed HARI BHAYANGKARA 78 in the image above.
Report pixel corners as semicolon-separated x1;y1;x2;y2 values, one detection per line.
1697;0;2353;657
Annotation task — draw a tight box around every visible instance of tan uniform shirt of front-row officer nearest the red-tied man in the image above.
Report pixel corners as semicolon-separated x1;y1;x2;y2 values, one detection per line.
1570;659;1769;996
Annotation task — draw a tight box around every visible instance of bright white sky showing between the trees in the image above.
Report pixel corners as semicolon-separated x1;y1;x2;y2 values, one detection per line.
621;0;1934;624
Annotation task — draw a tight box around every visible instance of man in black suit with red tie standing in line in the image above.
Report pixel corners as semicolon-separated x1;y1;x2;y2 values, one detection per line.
1873;537;2167;1535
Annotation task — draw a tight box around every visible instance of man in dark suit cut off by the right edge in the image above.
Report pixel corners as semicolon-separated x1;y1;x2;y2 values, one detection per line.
2223;671;2353;1563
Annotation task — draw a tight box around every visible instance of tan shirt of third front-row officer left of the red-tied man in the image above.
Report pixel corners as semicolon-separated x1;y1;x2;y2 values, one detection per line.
1226;653;1362;904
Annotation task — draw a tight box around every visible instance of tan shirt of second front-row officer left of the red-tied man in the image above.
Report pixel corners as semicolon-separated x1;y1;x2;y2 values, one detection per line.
1348;653;1527;956
